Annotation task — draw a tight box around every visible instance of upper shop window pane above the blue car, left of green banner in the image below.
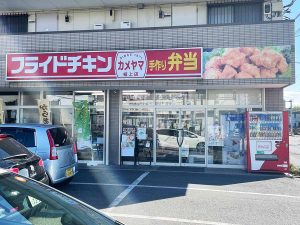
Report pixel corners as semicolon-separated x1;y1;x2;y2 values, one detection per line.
44;91;73;106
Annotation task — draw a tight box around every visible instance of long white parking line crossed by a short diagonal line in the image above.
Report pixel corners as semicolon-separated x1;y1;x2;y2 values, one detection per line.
70;182;300;200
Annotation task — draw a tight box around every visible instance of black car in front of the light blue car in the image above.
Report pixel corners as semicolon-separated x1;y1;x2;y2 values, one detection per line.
0;134;49;184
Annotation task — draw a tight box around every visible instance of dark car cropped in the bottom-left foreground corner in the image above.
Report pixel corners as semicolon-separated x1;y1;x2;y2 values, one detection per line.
0;173;118;225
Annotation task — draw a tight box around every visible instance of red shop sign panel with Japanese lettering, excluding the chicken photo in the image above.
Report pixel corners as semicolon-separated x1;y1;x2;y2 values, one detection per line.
6;48;202;81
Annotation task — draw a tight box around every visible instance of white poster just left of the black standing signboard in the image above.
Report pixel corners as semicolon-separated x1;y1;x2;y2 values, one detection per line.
121;126;136;157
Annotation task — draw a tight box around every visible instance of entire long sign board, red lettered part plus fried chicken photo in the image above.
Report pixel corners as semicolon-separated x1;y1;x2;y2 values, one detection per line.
6;45;292;81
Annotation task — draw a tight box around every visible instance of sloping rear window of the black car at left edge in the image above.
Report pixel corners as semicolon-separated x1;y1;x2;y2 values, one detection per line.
0;138;32;159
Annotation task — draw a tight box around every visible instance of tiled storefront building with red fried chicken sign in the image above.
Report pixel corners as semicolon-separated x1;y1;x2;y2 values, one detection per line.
0;1;295;168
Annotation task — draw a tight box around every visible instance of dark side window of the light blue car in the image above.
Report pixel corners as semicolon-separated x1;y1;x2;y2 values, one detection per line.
0;127;36;148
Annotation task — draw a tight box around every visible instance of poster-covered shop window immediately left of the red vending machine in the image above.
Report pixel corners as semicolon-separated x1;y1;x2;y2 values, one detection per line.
207;109;245;165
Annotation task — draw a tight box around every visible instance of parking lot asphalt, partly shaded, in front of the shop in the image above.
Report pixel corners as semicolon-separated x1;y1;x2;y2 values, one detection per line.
59;166;300;225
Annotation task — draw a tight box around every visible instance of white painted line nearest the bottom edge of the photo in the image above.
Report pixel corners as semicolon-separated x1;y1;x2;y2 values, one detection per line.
104;212;237;225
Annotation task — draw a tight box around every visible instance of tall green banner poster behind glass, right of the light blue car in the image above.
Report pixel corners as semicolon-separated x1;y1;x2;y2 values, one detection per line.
73;100;92;151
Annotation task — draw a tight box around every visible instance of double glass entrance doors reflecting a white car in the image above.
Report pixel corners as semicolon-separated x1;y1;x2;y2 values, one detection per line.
156;109;206;165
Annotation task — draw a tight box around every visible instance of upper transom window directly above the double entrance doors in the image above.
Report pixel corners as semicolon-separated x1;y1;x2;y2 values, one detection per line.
155;90;206;106
